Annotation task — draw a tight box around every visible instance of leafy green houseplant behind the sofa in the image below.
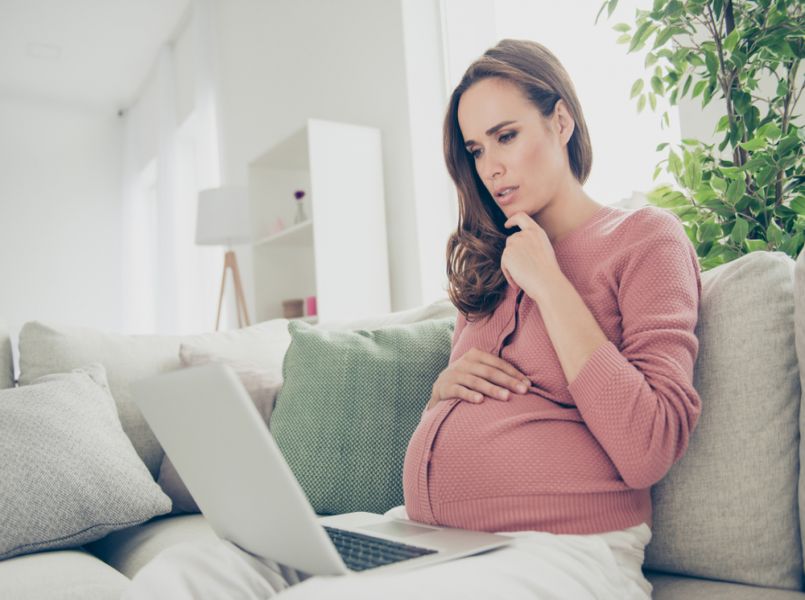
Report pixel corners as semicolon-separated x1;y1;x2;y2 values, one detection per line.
596;0;805;270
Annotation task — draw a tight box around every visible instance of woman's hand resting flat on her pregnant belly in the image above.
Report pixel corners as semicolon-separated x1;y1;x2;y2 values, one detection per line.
425;348;531;410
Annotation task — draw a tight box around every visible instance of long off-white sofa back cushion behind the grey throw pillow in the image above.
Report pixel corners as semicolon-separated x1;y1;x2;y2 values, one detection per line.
20;319;290;477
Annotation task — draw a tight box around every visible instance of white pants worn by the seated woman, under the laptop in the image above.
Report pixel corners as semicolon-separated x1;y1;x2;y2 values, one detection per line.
123;507;651;600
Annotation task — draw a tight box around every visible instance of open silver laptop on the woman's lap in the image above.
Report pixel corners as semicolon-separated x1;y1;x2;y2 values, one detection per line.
132;364;513;575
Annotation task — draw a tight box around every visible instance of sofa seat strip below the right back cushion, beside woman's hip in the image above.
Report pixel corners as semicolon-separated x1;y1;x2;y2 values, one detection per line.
646;571;805;600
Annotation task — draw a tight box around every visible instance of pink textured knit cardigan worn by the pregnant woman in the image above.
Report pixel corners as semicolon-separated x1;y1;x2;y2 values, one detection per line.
403;207;701;534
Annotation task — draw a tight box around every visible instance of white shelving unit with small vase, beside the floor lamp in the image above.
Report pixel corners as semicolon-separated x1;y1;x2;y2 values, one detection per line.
249;119;391;321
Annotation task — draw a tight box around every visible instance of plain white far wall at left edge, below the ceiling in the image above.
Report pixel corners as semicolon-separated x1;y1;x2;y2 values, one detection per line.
0;92;122;358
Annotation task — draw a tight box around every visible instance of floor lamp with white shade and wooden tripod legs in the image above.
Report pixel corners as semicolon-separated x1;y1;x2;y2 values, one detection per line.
196;186;252;331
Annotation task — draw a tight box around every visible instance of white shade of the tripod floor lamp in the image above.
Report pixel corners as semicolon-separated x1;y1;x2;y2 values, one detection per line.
196;186;252;246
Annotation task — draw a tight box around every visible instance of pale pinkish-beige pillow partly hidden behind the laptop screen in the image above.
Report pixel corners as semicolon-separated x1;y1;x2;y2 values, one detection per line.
157;344;282;514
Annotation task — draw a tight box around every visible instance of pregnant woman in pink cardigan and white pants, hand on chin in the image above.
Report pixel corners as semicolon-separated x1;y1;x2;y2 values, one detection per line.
126;40;701;600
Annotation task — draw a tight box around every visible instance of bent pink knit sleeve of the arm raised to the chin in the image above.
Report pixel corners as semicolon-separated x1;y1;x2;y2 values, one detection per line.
568;222;701;489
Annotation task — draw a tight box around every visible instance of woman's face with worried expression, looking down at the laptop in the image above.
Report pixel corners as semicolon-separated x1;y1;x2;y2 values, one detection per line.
458;78;573;217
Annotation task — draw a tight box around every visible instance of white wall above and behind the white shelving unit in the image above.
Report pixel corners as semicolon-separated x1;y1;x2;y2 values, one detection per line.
214;0;428;310
